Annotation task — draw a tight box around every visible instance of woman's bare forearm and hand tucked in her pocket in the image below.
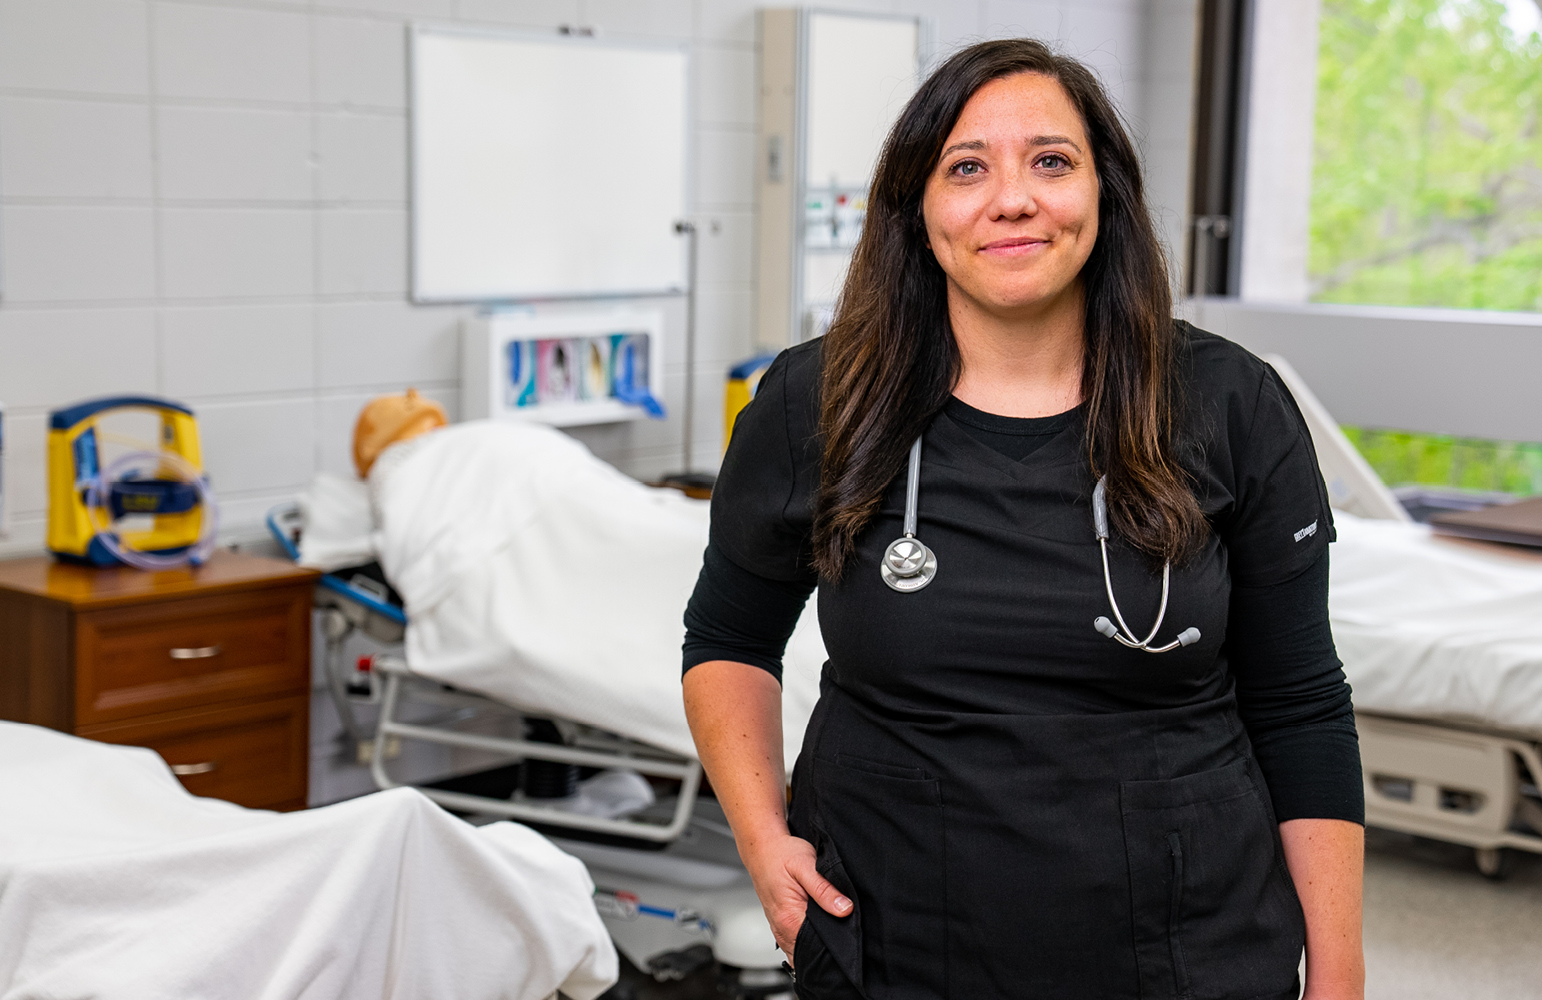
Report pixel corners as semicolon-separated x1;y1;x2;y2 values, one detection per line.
685;659;851;961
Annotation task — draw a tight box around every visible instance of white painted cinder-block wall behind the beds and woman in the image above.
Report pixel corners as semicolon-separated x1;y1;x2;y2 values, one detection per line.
0;0;1194;553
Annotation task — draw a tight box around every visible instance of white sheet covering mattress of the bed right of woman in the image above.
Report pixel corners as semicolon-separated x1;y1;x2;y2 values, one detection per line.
1328;512;1542;733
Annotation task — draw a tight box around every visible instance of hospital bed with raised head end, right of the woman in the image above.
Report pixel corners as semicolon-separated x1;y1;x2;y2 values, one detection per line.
1268;357;1542;878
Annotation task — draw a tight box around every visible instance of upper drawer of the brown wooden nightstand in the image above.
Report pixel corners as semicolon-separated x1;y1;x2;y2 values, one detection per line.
76;587;310;727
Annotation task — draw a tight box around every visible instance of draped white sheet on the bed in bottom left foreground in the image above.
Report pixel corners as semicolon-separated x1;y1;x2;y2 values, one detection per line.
0;723;617;1000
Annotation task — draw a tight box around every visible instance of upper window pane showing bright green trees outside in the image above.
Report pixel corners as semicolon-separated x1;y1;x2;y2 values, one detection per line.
1308;0;1542;310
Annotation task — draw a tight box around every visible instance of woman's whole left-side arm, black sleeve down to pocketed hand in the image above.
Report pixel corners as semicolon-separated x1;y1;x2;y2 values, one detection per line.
682;344;853;961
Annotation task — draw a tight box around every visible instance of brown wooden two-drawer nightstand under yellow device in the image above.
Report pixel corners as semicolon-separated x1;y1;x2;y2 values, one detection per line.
0;552;318;809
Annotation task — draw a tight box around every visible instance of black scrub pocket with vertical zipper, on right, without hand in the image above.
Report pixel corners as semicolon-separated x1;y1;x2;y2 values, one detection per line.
1119;758;1306;1000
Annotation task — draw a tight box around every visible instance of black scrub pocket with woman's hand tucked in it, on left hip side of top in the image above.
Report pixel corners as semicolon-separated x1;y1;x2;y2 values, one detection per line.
811;753;948;1000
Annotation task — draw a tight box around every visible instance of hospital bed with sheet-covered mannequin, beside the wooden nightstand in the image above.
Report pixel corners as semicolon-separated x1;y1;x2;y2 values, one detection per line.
270;422;825;997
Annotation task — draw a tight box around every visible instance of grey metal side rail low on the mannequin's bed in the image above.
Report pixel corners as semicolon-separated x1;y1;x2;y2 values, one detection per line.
370;656;702;843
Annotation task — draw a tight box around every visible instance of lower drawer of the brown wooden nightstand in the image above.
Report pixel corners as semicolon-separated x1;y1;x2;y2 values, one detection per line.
76;695;310;809
